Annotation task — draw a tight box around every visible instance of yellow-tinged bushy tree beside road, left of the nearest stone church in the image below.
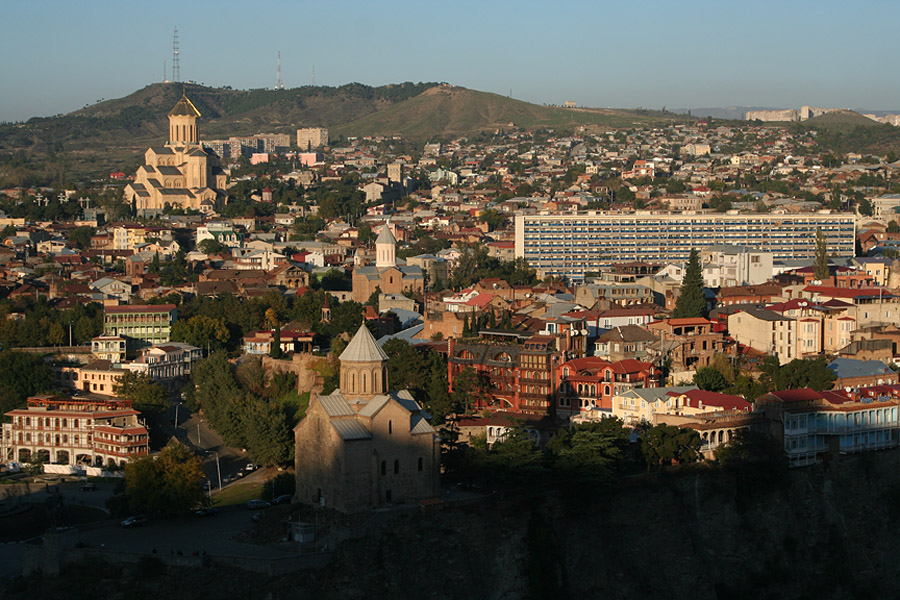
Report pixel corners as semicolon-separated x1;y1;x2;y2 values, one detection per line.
125;439;205;516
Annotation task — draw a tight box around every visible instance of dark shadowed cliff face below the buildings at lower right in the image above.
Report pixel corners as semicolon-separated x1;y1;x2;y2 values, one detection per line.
315;452;900;600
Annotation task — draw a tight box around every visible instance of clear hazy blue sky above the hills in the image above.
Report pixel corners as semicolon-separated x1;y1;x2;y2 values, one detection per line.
0;0;900;121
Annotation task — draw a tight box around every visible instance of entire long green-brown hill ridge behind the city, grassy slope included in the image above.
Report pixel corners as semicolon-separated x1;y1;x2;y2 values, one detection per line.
0;82;688;184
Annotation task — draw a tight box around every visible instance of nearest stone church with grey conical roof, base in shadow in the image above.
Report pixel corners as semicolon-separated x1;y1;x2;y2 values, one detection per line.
294;325;441;512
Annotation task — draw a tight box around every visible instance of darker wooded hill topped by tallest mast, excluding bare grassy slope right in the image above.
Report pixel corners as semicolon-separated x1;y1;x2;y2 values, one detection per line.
0;83;436;182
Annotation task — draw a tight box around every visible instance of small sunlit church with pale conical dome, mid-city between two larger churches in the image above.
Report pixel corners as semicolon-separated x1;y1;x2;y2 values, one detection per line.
353;225;425;303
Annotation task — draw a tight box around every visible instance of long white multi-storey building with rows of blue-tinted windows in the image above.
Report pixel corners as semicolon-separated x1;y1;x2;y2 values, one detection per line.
516;211;856;280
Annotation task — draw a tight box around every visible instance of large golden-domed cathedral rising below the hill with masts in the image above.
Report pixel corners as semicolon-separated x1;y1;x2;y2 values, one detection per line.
125;96;227;217
